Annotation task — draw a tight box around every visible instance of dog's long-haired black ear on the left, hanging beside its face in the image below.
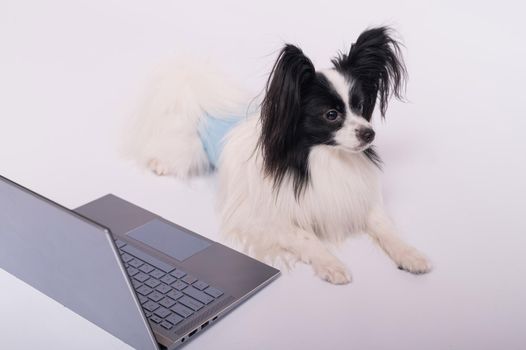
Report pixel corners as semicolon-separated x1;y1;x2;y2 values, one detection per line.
259;44;315;184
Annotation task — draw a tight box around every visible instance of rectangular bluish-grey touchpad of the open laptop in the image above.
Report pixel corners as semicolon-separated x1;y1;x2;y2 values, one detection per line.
127;219;210;261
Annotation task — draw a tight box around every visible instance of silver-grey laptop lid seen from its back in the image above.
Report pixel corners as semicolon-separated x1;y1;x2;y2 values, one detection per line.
0;176;158;350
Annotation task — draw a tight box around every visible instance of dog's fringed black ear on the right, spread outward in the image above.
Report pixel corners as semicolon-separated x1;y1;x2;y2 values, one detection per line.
332;27;407;120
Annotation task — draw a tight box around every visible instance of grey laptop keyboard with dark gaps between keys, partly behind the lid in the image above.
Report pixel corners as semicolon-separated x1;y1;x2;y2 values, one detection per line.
115;239;223;330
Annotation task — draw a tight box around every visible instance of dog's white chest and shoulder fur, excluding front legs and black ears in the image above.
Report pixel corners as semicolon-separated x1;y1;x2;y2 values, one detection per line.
219;118;381;245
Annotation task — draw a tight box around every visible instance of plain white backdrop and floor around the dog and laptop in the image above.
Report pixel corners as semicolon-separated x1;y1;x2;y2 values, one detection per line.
0;0;526;349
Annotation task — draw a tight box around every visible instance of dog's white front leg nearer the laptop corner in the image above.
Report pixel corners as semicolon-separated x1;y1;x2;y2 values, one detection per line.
279;227;351;284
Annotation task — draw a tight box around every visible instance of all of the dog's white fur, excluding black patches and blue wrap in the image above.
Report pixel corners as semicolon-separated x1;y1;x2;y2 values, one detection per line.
131;60;431;284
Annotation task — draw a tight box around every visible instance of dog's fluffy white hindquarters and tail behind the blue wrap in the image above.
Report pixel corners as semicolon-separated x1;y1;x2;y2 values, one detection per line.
124;58;252;178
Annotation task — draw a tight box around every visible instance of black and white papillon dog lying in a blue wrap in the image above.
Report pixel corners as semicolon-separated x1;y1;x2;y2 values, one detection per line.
130;27;431;284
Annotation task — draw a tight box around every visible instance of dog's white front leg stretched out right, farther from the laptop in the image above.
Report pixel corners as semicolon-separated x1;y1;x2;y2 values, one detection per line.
366;206;431;273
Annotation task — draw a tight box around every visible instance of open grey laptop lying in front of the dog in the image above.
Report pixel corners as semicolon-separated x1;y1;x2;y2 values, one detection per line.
0;176;280;350
